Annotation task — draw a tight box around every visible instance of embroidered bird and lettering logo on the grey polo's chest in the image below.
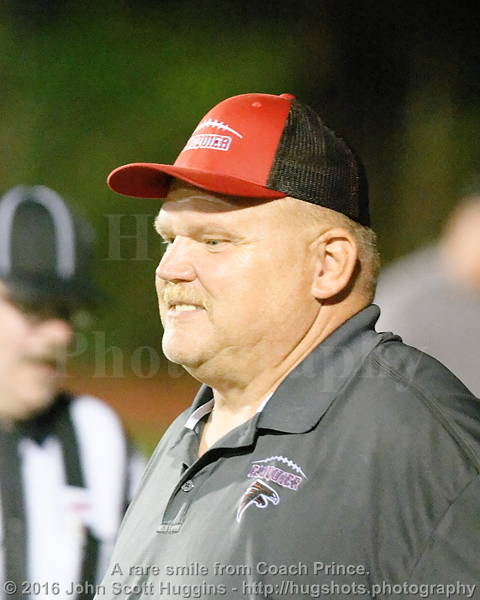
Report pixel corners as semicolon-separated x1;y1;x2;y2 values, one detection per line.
237;456;307;522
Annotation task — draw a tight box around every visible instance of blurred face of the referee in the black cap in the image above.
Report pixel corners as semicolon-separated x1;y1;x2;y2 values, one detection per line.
0;283;73;421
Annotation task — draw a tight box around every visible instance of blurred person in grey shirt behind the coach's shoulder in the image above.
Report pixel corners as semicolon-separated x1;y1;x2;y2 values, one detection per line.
375;192;480;396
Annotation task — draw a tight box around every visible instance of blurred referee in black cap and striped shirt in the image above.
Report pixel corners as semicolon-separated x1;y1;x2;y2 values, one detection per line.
0;186;143;599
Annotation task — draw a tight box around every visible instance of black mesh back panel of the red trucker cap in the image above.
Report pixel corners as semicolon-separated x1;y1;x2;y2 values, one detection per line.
266;100;370;226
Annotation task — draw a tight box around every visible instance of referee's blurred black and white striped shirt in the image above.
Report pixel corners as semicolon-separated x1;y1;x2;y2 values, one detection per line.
0;393;145;600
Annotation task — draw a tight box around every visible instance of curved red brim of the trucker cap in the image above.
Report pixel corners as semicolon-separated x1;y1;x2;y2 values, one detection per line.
107;163;286;199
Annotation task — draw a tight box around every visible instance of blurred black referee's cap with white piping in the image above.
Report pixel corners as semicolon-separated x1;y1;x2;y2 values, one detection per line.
0;185;103;309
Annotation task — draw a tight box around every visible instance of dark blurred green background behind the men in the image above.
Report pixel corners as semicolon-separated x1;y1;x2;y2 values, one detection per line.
0;0;480;452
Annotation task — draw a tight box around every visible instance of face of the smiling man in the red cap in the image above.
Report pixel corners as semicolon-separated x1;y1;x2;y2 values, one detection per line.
155;184;319;380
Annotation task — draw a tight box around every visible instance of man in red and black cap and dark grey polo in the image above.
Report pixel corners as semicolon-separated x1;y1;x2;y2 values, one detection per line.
98;94;480;599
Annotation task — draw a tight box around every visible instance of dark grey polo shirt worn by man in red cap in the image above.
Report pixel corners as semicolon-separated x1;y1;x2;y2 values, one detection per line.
98;306;480;599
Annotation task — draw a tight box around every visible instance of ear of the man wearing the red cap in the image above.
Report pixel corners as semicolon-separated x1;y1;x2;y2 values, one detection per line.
312;227;358;300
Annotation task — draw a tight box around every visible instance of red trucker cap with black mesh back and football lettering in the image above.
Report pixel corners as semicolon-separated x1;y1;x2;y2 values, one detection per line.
108;94;370;226
